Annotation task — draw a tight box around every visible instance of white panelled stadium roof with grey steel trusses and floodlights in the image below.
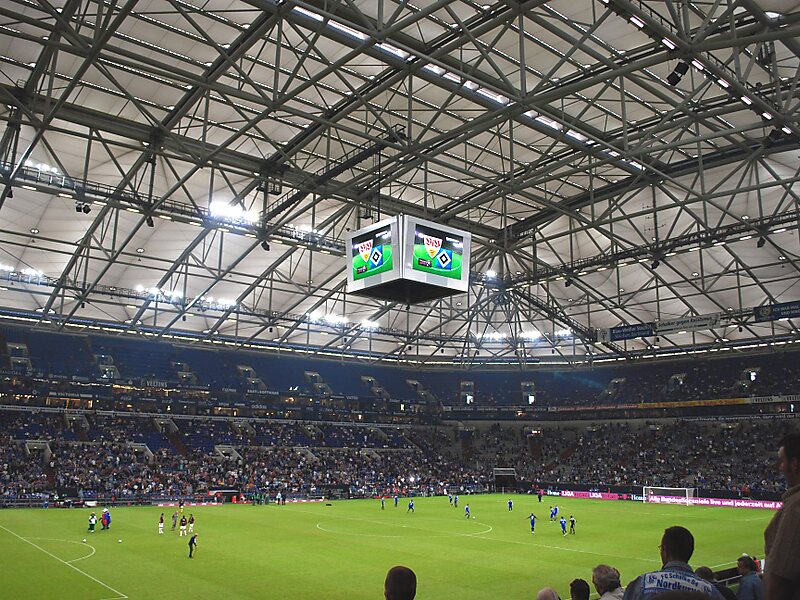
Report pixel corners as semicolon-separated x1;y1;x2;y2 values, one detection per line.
0;0;800;363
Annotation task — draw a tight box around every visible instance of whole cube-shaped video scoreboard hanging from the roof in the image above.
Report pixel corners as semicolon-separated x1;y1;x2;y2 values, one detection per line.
347;215;471;304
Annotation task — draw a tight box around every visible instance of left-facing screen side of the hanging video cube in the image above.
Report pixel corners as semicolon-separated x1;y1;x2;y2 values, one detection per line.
347;218;402;292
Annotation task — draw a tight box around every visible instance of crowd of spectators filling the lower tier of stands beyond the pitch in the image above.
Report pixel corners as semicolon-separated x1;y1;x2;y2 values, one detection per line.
0;411;788;499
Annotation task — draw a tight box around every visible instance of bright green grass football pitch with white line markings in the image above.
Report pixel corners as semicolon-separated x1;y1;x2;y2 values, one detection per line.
0;495;773;600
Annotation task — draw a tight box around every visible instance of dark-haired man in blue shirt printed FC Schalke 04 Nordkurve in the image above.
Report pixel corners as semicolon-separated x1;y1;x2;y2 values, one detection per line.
623;525;724;600
